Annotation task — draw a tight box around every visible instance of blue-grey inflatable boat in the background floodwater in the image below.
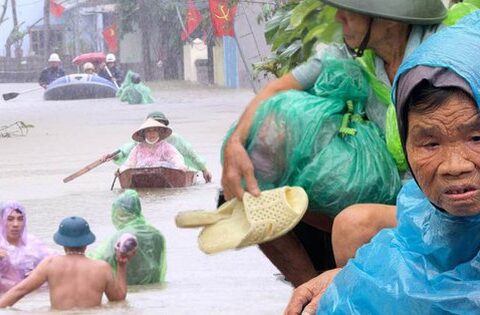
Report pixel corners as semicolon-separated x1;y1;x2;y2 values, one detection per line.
43;73;117;100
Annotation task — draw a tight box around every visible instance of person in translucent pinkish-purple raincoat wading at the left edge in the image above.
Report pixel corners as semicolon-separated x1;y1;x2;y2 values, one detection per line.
0;201;53;293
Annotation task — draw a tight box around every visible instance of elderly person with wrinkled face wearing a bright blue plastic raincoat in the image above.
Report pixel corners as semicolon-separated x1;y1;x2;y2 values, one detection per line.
286;11;480;314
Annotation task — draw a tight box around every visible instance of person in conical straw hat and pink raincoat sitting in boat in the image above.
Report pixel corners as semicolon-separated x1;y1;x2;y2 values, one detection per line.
125;118;187;170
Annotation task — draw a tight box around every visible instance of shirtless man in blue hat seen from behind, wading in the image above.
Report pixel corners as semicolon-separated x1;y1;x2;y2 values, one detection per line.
0;217;135;310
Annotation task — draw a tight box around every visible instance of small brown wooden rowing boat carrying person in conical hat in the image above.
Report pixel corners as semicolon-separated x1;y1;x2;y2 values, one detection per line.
118;167;197;188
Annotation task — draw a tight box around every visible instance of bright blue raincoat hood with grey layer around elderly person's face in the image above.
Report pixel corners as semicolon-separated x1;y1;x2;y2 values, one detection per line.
392;11;480;147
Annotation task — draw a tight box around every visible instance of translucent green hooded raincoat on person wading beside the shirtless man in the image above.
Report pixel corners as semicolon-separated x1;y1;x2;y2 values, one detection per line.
90;189;166;285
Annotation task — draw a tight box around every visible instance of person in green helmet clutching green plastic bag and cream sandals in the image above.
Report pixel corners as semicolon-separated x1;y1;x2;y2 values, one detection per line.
222;0;446;286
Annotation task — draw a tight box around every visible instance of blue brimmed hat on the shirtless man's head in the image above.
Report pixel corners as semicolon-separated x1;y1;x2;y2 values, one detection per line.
53;217;95;247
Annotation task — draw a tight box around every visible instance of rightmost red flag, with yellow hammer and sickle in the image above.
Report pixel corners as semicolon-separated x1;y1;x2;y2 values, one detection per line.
208;0;237;37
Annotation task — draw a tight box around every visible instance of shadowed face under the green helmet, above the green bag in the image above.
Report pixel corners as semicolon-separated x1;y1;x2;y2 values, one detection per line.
336;9;370;48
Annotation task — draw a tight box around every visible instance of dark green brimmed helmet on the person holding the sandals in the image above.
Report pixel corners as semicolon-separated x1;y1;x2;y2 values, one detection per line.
323;0;447;25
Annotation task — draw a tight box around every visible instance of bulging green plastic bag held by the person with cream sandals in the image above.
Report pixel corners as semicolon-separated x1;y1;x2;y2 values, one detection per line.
227;58;401;216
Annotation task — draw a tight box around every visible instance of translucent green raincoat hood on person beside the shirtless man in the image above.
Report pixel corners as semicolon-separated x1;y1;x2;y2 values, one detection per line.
112;189;145;230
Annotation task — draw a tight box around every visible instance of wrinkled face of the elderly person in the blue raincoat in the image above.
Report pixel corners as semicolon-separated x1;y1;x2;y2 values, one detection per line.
407;96;480;216
